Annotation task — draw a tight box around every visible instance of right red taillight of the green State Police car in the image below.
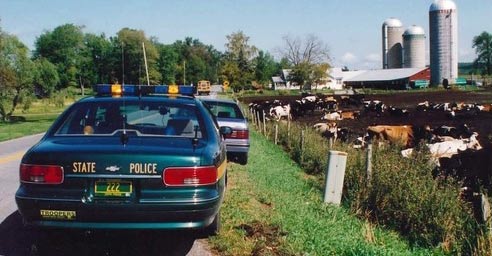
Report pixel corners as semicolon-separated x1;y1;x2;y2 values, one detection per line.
162;166;217;186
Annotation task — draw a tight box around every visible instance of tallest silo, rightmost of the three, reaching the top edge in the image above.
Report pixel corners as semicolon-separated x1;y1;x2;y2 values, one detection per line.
429;0;458;85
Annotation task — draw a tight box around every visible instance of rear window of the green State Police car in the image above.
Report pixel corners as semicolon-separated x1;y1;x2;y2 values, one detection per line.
55;102;201;138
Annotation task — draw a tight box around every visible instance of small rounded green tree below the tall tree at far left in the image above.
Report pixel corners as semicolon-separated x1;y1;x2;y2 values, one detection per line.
34;58;60;97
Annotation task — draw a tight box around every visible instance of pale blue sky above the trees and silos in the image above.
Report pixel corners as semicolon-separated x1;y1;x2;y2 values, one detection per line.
0;0;492;70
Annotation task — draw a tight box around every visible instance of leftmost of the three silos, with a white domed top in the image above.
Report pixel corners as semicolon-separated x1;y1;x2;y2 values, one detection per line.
382;18;403;69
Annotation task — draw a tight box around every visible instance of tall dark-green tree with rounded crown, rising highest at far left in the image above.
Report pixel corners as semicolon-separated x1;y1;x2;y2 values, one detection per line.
34;24;85;88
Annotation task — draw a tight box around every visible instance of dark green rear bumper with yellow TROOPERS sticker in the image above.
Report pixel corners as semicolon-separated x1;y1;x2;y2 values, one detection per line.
16;193;223;229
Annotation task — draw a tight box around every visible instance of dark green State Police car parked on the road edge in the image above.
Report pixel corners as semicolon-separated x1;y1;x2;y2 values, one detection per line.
15;84;232;233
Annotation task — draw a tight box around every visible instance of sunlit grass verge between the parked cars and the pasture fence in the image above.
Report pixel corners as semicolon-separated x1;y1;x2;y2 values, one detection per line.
211;131;441;255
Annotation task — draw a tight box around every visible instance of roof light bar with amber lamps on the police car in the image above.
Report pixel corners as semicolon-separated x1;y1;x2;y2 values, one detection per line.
93;84;194;97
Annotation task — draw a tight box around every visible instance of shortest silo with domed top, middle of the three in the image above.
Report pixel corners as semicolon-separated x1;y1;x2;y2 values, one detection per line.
403;25;425;68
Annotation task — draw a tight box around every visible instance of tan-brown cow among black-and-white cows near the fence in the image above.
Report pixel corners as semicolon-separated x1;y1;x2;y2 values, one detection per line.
366;125;432;148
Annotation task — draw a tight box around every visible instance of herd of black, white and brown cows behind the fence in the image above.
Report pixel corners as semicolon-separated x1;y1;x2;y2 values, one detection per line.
249;91;492;216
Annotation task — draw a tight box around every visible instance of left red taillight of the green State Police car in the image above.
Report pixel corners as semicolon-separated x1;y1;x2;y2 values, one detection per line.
20;164;63;184
